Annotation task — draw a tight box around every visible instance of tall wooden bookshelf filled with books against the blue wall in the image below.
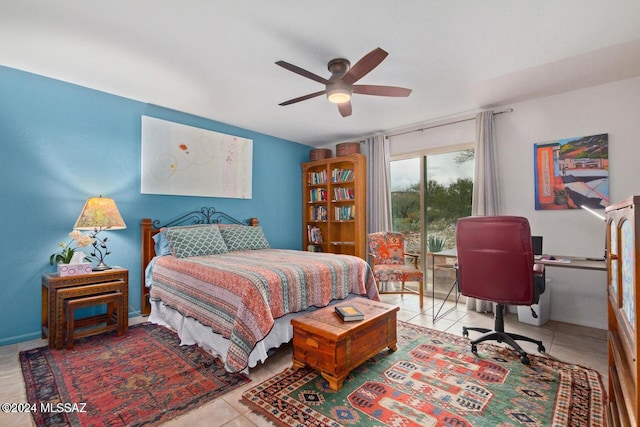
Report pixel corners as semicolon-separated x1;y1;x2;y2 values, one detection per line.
302;153;367;260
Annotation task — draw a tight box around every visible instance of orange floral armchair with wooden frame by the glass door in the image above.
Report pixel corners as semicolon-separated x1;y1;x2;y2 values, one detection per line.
368;231;424;308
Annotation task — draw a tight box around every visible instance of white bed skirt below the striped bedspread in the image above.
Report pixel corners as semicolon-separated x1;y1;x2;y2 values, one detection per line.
149;294;358;373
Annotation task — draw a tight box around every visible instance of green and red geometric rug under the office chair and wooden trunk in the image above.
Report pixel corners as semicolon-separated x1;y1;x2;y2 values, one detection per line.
242;322;606;427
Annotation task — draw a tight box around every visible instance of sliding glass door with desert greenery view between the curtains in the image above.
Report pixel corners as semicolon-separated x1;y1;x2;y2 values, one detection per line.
391;147;474;296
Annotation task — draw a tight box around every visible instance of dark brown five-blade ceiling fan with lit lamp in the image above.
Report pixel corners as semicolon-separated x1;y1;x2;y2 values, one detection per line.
276;47;411;117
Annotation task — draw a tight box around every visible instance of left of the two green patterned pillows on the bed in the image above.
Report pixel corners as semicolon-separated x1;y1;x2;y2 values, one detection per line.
167;224;228;258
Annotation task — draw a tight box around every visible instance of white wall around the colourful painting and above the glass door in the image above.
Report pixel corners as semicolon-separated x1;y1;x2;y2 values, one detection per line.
390;78;640;329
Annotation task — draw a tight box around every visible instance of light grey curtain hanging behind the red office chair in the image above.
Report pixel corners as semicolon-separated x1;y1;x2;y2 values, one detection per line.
467;111;500;312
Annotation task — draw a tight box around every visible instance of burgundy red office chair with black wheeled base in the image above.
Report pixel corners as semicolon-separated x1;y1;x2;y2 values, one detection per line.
456;216;545;365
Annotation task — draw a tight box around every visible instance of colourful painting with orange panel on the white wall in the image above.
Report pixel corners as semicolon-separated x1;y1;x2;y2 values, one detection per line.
533;133;609;210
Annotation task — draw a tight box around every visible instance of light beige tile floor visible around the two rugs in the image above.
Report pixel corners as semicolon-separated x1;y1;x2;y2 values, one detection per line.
0;295;607;427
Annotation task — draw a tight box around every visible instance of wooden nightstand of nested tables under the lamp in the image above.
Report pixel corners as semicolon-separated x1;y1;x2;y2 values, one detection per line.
42;267;129;349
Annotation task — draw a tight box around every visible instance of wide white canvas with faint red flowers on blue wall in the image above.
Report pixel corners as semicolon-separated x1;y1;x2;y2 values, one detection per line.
141;116;253;199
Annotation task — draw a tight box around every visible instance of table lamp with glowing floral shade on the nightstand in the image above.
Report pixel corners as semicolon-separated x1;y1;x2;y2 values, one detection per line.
73;196;127;271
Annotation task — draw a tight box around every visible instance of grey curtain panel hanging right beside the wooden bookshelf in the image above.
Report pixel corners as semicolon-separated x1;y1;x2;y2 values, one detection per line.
364;135;392;234
